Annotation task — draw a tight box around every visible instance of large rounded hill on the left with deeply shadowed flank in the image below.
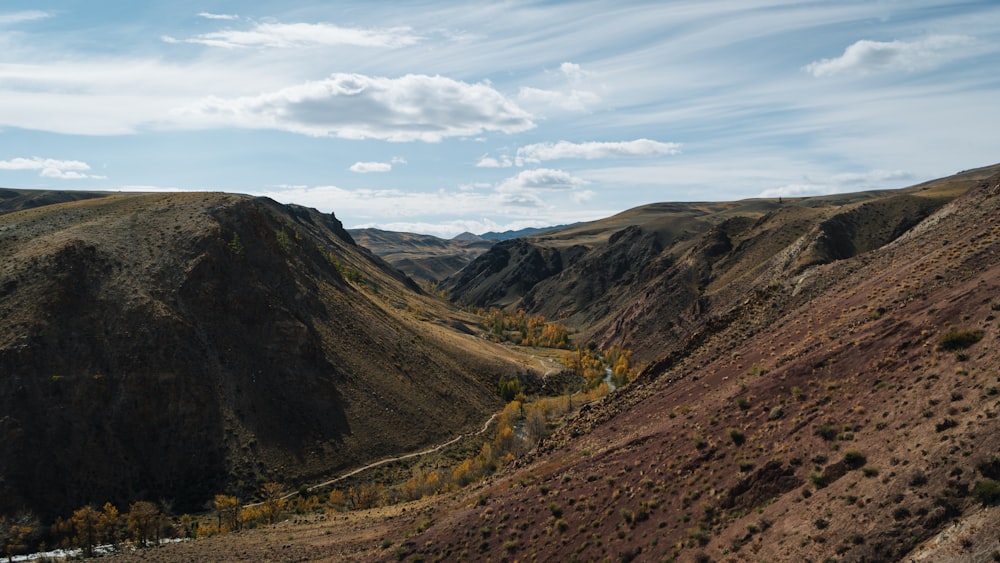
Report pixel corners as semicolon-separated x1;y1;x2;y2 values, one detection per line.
0;191;526;517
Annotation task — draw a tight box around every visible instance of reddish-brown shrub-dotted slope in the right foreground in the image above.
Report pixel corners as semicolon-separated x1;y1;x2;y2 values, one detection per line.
396;176;1000;561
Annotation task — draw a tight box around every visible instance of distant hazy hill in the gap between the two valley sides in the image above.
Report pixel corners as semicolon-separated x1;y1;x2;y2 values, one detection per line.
348;229;493;284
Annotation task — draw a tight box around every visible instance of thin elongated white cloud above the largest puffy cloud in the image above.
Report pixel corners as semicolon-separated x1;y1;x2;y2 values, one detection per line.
163;21;421;49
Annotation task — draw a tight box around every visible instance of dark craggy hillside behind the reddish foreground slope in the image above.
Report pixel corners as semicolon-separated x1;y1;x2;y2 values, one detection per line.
442;166;1000;366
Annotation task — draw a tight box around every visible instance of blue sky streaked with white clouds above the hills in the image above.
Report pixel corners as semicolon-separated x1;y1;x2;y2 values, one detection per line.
0;0;1000;238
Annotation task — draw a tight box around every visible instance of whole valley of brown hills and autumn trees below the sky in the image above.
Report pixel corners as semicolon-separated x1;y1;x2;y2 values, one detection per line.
0;165;1000;561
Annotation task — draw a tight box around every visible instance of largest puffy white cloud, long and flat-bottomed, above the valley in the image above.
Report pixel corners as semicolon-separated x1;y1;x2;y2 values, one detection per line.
178;74;535;142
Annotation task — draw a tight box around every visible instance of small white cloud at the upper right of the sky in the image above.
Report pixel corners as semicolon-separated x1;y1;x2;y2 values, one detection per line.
804;35;975;77
